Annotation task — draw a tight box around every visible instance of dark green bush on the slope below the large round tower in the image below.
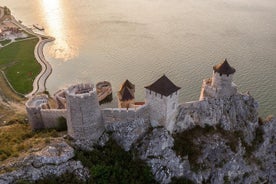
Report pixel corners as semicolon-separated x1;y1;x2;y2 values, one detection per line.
75;140;156;184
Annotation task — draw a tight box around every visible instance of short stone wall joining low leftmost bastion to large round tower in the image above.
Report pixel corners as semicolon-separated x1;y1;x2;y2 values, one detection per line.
41;109;67;128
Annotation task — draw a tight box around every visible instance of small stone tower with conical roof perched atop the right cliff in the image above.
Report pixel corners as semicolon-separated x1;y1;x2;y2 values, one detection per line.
199;59;237;100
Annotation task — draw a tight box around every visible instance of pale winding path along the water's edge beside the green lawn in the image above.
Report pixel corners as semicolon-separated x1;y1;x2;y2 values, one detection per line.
11;18;55;98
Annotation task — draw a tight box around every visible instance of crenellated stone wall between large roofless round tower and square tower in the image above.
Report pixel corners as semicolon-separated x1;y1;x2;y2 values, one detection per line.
101;105;149;124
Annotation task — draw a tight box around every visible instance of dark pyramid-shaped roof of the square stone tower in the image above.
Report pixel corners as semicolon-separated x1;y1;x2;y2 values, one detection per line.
145;75;180;96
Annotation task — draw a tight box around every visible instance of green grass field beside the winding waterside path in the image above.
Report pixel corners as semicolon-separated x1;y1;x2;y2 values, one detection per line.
0;38;41;94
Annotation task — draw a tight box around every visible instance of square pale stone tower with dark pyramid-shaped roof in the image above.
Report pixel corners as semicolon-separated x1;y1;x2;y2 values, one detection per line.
145;75;180;132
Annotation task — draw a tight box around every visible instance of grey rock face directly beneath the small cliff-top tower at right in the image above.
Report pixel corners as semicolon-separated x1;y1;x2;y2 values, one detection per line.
175;93;258;143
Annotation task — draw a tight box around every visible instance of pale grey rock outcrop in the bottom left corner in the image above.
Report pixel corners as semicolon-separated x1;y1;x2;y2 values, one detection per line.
0;141;89;184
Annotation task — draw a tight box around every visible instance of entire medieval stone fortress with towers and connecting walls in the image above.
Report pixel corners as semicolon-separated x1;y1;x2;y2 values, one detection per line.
26;59;242;143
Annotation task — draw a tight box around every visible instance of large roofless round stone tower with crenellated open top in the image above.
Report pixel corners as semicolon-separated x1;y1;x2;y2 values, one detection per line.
65;84;104;143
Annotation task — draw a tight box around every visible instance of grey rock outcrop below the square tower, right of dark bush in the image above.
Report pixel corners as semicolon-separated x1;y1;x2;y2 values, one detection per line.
136;128;189;183
